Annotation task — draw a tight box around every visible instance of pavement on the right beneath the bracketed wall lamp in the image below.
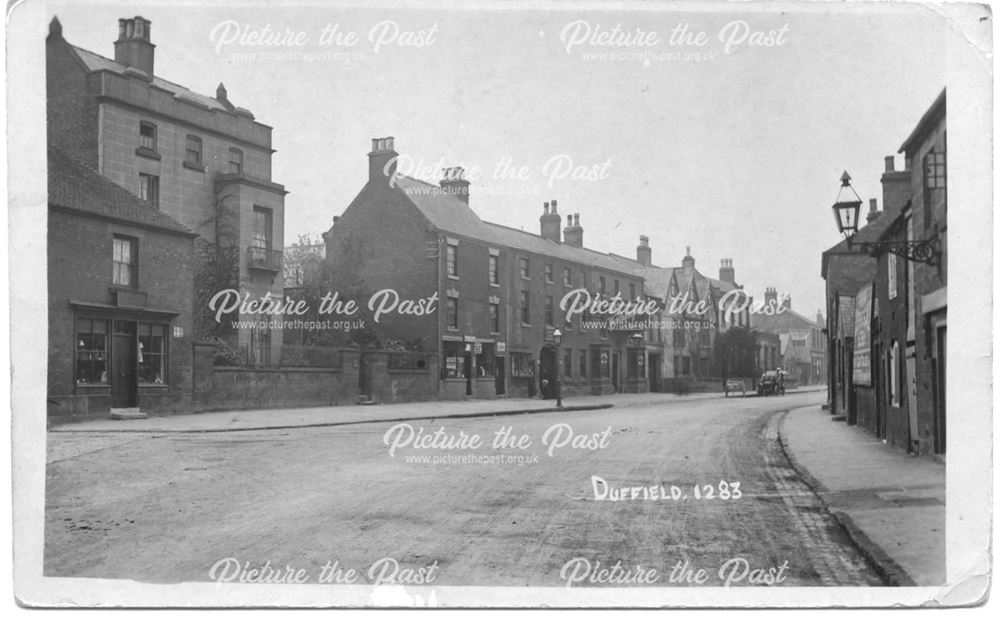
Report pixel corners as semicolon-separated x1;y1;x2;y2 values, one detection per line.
779;406;947;586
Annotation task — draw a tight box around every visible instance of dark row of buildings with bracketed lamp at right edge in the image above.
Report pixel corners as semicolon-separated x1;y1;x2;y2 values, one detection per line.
823;91;947;454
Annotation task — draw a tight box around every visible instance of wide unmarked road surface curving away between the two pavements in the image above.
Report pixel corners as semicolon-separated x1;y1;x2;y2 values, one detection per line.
45;393;881;587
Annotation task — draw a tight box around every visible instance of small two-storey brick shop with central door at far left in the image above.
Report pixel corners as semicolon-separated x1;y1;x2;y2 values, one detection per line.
47;147;195;419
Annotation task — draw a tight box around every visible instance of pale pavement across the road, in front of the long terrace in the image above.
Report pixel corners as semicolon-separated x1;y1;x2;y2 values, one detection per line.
50;389;788;433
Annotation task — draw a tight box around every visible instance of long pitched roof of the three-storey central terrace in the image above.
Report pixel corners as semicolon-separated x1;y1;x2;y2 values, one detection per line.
395;175;652;274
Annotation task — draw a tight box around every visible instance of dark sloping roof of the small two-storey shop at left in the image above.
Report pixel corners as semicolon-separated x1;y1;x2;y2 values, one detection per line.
48;146;195;237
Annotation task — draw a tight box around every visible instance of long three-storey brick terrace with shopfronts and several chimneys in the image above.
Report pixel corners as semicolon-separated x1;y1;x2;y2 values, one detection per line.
320;137;648;398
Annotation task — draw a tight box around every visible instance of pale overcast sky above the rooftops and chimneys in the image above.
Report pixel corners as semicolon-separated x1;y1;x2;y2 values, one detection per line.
50;2;946;317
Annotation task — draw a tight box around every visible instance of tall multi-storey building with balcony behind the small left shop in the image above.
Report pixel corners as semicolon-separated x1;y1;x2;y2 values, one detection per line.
46;17;286;364
